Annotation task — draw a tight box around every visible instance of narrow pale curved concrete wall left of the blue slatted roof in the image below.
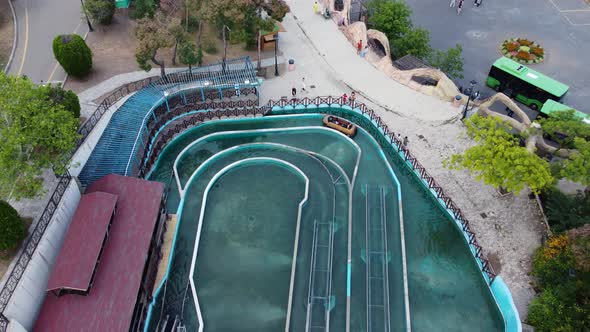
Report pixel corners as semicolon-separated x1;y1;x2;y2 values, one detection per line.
69;94;133;176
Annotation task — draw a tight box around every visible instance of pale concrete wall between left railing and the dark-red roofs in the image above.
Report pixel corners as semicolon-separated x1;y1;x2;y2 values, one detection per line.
4;179;81;331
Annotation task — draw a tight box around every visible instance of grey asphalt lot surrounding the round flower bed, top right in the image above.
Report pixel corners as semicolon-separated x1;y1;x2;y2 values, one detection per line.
407;0;590;113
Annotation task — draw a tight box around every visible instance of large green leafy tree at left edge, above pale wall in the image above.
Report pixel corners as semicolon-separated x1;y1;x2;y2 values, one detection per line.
0;73;79;199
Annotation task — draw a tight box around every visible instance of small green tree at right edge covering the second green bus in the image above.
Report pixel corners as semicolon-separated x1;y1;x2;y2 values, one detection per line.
538;110;590;150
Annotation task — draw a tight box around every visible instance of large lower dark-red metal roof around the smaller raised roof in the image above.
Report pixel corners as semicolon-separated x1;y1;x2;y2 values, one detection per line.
34;174;164;332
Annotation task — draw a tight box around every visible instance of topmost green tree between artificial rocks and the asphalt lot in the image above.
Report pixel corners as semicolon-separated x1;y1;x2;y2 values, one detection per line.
367;0;412;44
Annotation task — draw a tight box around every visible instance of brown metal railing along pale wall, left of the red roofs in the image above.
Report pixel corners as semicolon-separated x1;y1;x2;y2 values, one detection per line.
0;174;72;331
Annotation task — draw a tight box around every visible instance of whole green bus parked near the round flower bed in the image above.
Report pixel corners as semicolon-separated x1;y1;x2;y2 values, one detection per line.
486;57;569;110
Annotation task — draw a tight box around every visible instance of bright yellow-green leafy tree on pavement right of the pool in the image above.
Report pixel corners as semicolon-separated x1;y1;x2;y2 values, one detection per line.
446;115;554;193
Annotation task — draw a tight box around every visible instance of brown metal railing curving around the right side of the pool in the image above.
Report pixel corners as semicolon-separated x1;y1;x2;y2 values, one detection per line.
267;96;496;285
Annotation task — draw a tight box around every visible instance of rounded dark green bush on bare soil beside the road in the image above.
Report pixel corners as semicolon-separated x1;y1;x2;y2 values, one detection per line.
53;34;92;77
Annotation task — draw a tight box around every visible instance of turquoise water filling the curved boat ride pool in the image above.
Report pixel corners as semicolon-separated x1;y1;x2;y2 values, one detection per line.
150;111;503;331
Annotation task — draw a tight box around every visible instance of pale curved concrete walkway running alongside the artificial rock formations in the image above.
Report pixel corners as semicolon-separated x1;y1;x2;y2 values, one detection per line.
286;0;460;122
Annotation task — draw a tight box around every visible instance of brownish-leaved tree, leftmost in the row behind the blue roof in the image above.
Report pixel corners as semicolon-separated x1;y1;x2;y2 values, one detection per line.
135;12;178;77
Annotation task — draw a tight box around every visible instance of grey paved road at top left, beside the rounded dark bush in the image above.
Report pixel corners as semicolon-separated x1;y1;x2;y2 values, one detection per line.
9;0;88;83
